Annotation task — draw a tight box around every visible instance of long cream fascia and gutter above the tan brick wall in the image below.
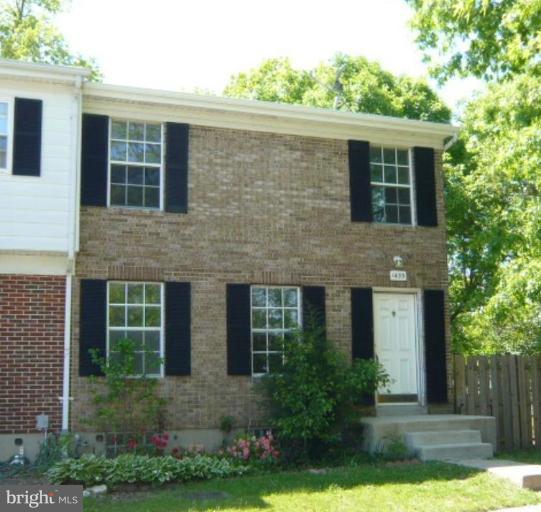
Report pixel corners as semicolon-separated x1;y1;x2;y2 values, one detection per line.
83;83;458;148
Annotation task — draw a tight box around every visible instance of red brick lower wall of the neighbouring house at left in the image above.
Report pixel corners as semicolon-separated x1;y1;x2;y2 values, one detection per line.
0;275;66;433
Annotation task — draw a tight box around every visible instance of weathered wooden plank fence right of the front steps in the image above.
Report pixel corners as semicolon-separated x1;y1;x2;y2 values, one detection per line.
454;355;541;450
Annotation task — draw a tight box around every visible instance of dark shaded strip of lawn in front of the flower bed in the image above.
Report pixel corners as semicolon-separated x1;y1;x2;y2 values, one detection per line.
85;462;486;512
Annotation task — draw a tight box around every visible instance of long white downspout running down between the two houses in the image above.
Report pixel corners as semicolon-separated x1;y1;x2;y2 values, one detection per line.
61;76;83;432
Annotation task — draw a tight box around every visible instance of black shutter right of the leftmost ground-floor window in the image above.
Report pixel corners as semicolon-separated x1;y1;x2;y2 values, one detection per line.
165;282;191;375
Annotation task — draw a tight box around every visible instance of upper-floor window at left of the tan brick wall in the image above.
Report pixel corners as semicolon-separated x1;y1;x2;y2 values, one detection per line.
109;119;163;208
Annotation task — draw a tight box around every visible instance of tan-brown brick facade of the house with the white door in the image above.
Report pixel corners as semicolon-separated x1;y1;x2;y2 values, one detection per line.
71;126;450;430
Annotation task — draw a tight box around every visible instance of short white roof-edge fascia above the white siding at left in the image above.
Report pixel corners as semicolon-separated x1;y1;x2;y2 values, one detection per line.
0;59;90;84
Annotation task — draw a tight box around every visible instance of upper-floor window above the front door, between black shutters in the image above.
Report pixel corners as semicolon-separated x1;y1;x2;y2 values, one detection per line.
370;146;413;224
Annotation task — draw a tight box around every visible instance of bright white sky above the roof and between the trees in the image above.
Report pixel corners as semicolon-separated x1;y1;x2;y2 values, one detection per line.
56;0;481;112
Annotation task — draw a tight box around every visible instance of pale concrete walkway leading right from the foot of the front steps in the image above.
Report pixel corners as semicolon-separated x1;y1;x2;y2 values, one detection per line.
447;459;541;490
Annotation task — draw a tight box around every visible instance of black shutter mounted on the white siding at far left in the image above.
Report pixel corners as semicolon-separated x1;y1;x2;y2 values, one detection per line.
13;98;43;176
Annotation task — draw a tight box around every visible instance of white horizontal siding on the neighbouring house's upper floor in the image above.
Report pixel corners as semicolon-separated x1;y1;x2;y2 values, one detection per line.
0;80;77;254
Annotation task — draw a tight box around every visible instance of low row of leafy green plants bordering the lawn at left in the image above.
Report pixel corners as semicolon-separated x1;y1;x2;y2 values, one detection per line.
47;454;248;487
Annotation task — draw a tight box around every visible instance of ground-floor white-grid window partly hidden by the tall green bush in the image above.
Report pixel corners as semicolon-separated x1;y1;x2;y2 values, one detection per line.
251;286;301;375
